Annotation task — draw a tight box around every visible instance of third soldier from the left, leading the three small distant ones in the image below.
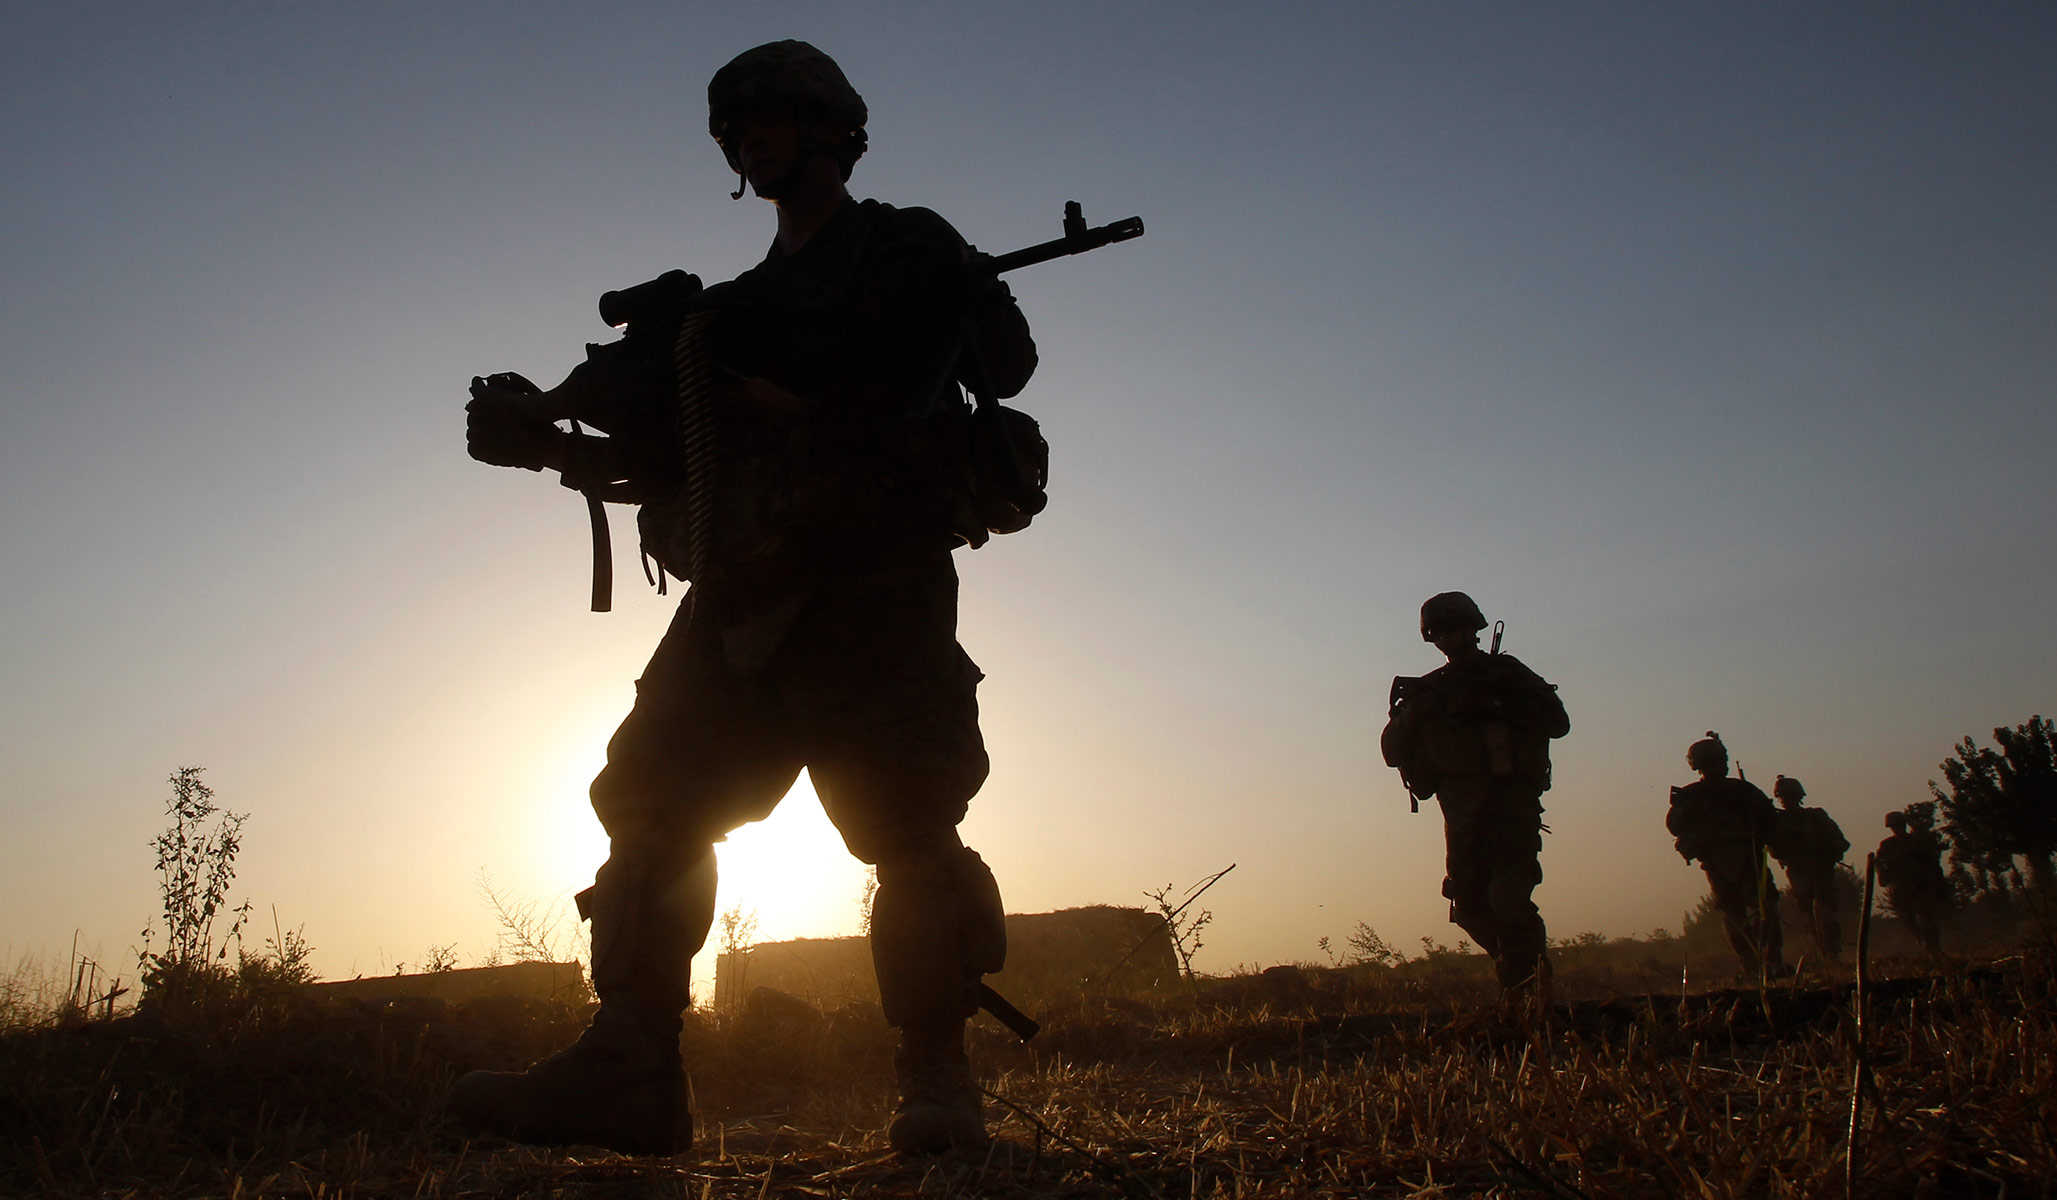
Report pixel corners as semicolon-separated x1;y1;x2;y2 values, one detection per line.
1664;729;1785;976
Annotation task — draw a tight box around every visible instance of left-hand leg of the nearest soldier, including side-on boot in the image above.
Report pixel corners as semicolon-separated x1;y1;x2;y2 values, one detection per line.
450;605;798;1153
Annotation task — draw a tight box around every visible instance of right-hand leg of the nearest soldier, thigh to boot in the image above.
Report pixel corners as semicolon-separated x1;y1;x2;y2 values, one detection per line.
786;554;1006;1155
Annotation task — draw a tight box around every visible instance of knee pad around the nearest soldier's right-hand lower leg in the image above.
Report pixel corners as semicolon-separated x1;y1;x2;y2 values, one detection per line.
872;832;1008;1027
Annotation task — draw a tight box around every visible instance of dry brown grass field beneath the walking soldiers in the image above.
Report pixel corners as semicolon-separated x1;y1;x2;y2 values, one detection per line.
0;957;2057;1200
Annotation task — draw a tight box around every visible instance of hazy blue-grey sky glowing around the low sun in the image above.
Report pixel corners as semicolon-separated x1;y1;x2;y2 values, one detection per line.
0;2;2057;992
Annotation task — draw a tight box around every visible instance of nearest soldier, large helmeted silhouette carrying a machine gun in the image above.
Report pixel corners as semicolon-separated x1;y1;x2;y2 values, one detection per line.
450;41;1037;1153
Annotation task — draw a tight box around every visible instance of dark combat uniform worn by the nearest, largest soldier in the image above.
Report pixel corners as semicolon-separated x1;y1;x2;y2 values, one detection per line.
592;202;1035;1127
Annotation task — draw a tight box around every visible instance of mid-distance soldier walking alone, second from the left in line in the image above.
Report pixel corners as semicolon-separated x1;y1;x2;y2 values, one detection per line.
1378;591;1572;990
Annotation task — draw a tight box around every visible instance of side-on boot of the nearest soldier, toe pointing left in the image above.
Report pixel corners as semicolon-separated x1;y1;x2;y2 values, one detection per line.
446;1007;693;1155
